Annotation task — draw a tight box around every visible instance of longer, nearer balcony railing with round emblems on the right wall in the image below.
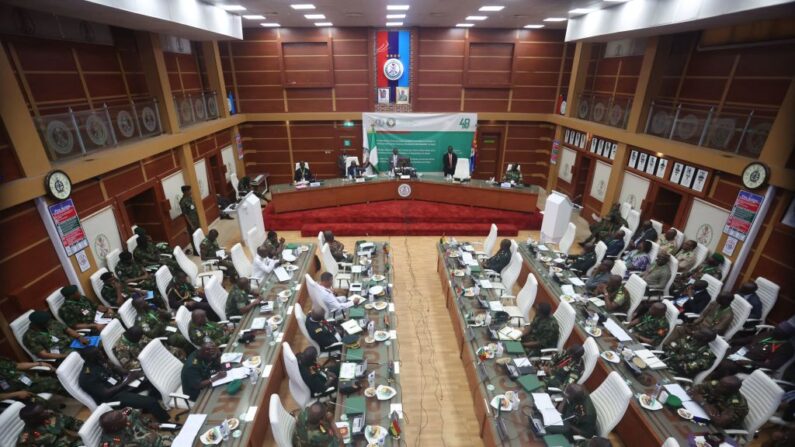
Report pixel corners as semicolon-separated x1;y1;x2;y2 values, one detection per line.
645;101;774;158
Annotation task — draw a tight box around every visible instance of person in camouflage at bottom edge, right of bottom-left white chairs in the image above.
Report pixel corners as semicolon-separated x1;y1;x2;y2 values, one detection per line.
99;407;173;447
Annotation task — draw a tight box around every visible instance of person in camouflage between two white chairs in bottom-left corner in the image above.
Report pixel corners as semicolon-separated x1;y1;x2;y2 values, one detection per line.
17;403;83;447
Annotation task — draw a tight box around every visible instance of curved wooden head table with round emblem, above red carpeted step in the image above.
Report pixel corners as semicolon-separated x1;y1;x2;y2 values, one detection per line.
270;173;541;213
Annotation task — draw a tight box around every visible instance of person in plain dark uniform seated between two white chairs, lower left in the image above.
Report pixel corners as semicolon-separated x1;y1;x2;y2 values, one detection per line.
78;346;169;422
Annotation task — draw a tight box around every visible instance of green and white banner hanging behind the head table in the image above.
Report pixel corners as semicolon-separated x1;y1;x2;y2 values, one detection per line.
362;113;478;172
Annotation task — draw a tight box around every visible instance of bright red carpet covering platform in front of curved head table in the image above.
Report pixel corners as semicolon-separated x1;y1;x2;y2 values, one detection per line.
263;200;542;236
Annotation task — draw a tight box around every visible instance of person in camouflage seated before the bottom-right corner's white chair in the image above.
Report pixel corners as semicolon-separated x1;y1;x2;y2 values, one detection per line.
690;376;748;428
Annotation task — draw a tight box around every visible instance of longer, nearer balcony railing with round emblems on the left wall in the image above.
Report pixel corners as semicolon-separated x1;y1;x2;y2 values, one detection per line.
34;99;163;161
